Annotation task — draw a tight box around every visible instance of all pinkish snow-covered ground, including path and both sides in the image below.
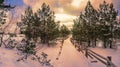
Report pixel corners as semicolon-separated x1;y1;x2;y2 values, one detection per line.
0;38;120;67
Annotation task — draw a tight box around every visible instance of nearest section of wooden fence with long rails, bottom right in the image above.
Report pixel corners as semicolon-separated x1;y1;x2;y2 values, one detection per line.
85;49;117;67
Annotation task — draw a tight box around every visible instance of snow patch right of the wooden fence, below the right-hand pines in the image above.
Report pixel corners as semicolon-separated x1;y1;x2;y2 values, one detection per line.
92;46;120;67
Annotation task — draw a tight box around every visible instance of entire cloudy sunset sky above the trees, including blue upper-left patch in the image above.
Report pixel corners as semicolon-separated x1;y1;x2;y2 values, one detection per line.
5;0;120;27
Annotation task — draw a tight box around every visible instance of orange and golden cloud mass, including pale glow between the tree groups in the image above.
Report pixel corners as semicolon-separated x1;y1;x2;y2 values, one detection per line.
23;0;120;26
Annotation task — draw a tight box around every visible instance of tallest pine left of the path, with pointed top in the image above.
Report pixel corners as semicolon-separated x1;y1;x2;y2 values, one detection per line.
36;3;59;44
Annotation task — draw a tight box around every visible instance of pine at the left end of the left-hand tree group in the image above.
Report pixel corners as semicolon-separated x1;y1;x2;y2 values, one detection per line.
20;7;35;40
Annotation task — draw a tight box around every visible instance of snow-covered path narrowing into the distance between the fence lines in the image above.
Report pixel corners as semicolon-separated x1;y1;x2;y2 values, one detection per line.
51;38;91;67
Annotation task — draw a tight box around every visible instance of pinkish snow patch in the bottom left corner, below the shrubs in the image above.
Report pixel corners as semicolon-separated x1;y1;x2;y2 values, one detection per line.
0;48;40;67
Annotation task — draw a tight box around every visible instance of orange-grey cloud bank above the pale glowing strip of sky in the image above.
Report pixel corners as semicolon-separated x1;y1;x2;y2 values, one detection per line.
23;0;112;15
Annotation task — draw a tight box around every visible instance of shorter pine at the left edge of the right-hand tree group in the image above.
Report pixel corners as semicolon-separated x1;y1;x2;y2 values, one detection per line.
72;13;88;45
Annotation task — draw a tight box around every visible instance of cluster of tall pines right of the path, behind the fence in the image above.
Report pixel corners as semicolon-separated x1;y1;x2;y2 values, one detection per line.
72;1;119;48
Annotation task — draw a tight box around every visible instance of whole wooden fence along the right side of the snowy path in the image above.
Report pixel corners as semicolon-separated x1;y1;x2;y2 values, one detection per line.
70;38;117;67
